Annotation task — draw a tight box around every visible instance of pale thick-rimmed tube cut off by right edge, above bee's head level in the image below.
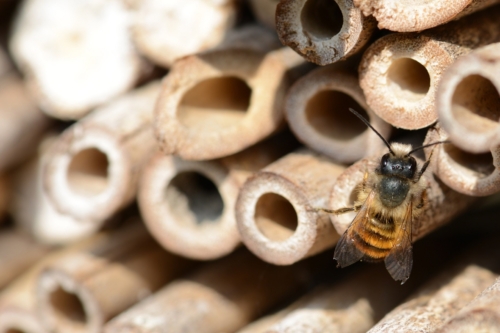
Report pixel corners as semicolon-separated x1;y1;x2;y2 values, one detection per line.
436;43;500;153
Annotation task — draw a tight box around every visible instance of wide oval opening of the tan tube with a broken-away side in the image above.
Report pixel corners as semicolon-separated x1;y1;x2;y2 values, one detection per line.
177;77;252;131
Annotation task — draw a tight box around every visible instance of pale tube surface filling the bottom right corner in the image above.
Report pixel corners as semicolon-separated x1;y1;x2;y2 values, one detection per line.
436;279;500;333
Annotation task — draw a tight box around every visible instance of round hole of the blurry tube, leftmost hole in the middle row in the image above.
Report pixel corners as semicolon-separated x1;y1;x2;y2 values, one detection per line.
67;148;109;196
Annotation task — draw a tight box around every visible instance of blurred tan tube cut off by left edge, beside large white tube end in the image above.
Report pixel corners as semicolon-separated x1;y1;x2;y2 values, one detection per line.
0;73;50;171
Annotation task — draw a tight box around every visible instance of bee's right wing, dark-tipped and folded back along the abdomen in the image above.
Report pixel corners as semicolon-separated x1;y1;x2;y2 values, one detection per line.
384;201;413;284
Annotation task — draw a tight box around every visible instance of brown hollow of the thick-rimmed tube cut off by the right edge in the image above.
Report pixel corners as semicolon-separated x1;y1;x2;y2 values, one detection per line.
451;75;500;133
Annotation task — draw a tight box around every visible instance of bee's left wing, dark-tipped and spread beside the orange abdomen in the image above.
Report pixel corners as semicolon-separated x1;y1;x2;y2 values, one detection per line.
333;191;375;267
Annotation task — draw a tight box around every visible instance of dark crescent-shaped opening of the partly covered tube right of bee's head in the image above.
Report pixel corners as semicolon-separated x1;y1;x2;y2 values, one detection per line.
444;144;495;178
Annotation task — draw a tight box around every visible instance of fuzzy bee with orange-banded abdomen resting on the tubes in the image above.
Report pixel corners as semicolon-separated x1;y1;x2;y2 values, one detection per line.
321;109;447;284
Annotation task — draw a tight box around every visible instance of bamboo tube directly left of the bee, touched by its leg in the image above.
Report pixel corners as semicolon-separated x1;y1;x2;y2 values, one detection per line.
236;151;344;265
